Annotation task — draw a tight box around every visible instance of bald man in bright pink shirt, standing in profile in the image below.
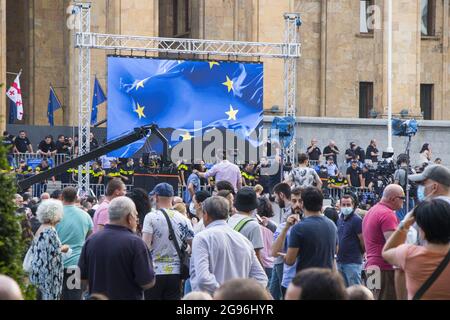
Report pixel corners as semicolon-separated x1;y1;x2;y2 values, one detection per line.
363;184;405;300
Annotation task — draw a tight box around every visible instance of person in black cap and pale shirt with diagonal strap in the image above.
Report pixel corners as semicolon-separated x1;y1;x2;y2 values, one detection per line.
228;187;264;261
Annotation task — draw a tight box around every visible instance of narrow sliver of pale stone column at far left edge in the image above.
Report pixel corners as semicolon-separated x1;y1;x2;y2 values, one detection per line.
0;0;8;132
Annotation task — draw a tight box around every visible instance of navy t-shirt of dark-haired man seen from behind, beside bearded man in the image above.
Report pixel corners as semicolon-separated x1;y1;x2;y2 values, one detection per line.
289;215;337;272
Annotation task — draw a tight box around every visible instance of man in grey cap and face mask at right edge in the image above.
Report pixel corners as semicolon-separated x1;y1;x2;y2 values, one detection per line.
408;164;450;203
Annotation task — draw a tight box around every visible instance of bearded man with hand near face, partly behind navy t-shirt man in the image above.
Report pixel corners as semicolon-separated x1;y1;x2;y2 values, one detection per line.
270;188;303;299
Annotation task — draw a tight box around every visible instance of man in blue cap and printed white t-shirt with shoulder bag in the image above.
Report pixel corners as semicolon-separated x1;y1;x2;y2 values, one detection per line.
142;183;194;300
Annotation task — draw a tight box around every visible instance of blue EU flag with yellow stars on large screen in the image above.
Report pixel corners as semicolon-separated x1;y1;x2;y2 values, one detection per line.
108;57;264;157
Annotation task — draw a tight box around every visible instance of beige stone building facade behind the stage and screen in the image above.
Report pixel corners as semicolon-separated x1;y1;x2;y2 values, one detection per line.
0;0;450;132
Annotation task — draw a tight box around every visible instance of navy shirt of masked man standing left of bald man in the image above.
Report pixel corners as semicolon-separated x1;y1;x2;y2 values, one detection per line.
337;213;362;264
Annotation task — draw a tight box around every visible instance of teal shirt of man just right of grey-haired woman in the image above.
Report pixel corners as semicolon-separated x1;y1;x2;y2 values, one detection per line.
56;206;94;268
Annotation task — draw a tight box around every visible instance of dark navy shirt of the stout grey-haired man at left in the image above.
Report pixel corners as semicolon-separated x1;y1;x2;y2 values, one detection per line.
78;224;155;300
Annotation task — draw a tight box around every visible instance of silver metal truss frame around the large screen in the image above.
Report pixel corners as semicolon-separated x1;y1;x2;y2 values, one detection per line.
75;3;301;191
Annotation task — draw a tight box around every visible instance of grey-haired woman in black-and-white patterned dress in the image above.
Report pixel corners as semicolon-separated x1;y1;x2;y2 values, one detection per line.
30;199;69;300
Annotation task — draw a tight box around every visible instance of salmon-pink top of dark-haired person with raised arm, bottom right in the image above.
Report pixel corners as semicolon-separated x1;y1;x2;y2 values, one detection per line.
395;244;450;300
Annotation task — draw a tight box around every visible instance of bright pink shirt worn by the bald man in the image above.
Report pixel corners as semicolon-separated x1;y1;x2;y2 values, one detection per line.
363;203;398;270
